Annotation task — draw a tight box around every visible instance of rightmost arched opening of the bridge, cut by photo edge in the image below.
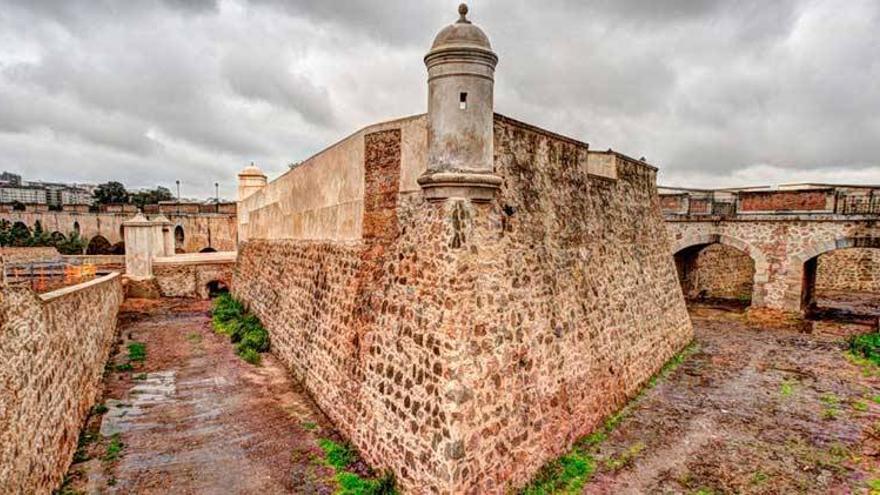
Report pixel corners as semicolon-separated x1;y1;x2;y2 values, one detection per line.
801;246;880;321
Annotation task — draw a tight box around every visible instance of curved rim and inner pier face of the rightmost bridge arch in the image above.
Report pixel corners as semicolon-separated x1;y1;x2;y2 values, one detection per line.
786;236;880;314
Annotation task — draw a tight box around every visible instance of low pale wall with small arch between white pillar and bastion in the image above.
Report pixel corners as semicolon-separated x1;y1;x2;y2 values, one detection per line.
153;252;237;299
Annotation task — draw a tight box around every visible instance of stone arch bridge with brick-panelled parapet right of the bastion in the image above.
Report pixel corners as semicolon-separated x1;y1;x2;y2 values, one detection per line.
660;186;880;313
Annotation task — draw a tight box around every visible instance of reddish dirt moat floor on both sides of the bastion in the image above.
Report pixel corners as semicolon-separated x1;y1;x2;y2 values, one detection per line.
62;300;880;494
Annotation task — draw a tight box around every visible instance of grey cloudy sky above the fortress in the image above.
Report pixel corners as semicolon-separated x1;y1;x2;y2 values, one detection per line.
0;0;880;197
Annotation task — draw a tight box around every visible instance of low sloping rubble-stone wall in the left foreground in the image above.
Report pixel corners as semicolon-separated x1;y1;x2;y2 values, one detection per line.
0;274;123;494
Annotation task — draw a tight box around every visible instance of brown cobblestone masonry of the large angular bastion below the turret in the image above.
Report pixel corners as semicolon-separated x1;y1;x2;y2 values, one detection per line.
234;117;692;493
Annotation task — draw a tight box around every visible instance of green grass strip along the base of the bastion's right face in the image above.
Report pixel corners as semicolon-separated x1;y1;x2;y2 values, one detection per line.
520;342;698;495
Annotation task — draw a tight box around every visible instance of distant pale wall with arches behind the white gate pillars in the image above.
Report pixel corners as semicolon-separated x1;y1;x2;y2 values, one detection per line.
0;211;237;253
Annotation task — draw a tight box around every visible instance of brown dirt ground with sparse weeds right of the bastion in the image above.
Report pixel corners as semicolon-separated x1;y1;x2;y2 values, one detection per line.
584;308;880;494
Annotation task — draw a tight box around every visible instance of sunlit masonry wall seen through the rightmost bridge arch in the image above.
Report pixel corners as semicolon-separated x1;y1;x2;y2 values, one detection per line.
816;248;880;294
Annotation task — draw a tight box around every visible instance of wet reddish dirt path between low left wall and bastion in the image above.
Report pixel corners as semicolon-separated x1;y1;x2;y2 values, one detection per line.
62;300;337;494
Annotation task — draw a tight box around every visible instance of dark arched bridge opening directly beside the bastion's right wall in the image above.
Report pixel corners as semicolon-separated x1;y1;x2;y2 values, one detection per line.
674;242;755;308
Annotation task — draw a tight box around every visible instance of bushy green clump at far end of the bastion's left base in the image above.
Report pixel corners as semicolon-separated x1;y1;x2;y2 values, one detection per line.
212;294;269;365
